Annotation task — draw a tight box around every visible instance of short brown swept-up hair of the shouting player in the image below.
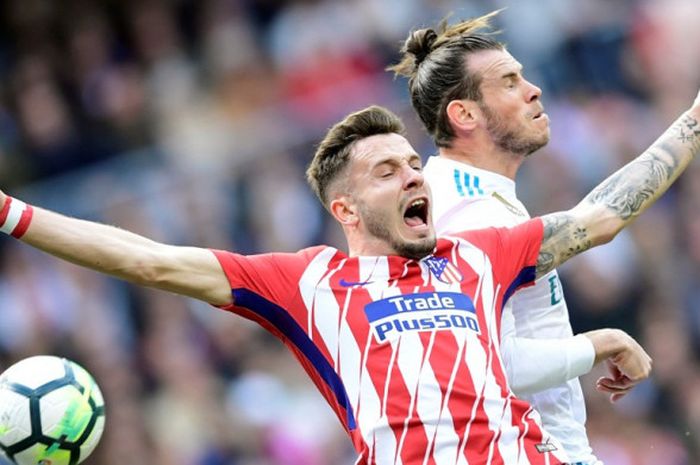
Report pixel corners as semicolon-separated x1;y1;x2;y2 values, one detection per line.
306;105;406;208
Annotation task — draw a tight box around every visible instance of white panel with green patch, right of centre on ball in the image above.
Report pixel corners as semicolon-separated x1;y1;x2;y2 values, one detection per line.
39;385;93;442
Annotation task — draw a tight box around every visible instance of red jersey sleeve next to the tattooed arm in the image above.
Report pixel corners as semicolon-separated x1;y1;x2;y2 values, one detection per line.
457;218;544;303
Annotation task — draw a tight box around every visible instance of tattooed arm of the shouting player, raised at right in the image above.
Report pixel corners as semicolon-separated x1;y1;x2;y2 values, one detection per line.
537;93;700;277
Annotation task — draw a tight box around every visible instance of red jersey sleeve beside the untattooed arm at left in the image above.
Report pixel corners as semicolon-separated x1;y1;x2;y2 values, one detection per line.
212;247;321;311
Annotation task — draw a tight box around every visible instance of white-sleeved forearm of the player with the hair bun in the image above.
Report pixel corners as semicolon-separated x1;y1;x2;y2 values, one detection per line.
501;335;595;396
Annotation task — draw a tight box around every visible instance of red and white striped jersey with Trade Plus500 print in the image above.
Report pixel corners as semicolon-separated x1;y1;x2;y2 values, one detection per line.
214;219;566;465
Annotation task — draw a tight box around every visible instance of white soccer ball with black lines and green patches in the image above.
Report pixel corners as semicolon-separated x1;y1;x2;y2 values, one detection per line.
0;355;105;465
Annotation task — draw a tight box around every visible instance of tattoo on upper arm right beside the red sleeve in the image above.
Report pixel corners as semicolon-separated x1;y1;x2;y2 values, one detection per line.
536;212;593;276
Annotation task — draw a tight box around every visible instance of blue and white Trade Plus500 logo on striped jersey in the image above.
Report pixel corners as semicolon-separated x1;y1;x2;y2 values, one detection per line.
365;292;479;342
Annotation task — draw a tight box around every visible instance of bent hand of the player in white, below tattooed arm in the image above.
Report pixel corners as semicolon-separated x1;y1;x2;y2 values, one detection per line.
586;329;652;402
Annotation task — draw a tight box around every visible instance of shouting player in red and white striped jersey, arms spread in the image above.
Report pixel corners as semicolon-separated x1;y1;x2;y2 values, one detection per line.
0;96;700;465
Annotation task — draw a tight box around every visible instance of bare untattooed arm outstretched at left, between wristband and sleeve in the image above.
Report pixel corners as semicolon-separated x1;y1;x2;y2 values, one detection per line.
0;192;232;305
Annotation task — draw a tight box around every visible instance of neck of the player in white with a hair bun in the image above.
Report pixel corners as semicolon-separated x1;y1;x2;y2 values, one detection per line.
438;138;525;181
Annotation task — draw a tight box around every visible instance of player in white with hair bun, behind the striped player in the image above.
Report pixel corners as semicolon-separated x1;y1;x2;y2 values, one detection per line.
389;12;634;464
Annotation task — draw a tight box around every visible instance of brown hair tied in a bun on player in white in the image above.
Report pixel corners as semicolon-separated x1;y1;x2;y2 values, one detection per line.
387;10;505;147
